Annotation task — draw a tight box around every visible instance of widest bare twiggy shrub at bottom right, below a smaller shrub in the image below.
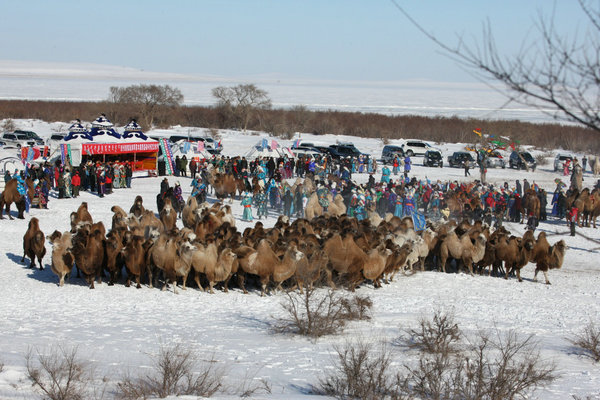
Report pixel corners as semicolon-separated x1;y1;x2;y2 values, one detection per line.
402;331;556;400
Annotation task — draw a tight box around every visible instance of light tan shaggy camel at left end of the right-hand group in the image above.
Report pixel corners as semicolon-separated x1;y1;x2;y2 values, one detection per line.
440;232;486;275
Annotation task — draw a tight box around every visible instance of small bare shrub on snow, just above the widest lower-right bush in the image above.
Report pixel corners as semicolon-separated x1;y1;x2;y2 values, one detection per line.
405;310;461;355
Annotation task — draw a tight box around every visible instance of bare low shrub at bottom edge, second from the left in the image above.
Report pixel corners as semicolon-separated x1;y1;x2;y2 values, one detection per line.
117;344;224;399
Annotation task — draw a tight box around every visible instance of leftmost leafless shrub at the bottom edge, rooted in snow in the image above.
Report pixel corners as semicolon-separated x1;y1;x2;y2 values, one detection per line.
25;346;93;400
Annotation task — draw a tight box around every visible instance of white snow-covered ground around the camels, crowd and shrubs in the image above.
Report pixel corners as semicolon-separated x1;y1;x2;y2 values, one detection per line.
0;120;600;400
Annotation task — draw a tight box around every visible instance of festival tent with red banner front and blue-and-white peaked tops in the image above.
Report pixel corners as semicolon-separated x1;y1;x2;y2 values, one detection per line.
58;114;158;170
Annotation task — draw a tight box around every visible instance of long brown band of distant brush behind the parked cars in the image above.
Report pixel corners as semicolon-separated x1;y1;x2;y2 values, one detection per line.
0;95;600;153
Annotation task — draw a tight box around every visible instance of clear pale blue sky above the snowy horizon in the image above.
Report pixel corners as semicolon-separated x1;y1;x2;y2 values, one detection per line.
0;0;596;81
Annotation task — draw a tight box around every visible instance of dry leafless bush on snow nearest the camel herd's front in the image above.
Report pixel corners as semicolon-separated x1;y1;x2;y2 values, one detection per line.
273;287;373;338
